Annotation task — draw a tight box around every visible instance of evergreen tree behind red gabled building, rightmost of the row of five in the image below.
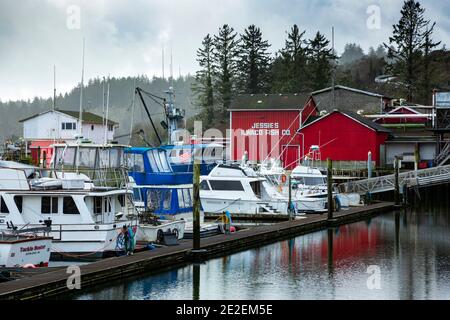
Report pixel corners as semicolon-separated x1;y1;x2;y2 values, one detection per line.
307;31;337;91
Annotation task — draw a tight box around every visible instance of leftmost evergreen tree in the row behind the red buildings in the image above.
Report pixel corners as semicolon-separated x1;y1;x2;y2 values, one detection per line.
192;34;214;127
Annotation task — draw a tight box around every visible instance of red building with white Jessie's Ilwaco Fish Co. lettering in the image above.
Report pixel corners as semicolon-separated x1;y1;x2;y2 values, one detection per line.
229;94;318;168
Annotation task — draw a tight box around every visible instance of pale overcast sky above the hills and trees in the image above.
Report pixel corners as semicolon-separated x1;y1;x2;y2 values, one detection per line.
0;0;450;101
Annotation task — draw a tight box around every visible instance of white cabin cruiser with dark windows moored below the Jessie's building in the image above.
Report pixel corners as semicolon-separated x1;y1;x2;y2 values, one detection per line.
200;165;325;215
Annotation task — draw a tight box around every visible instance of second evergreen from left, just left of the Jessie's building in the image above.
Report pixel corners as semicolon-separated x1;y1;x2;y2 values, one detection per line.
213;24;239;119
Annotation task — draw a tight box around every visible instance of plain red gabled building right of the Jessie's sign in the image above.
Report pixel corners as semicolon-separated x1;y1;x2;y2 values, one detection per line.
300;110;390;165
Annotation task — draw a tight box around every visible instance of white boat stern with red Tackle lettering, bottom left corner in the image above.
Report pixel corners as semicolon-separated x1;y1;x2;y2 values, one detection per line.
0;229;52;268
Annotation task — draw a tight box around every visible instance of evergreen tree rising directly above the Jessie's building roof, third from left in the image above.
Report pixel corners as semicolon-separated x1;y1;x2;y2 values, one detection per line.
239;25;270;94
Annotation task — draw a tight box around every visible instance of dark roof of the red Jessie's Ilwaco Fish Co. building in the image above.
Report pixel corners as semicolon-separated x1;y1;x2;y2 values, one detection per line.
230;93;311;110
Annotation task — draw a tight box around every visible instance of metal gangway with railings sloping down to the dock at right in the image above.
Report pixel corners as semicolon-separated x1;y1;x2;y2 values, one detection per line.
338;165;450;195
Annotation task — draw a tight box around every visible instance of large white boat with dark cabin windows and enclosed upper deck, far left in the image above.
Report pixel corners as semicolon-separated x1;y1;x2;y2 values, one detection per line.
0;143;142;259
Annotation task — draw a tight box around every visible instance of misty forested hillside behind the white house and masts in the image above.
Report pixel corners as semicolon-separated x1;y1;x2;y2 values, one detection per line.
0;76;196;141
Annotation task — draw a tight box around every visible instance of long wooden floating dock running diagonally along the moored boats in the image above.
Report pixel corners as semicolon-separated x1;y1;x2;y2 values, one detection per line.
0;202;394;300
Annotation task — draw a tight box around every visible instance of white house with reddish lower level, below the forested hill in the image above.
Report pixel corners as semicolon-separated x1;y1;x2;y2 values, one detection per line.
19;109;118;164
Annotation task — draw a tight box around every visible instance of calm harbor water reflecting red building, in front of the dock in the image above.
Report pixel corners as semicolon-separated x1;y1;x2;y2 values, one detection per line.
71;189;450;300
